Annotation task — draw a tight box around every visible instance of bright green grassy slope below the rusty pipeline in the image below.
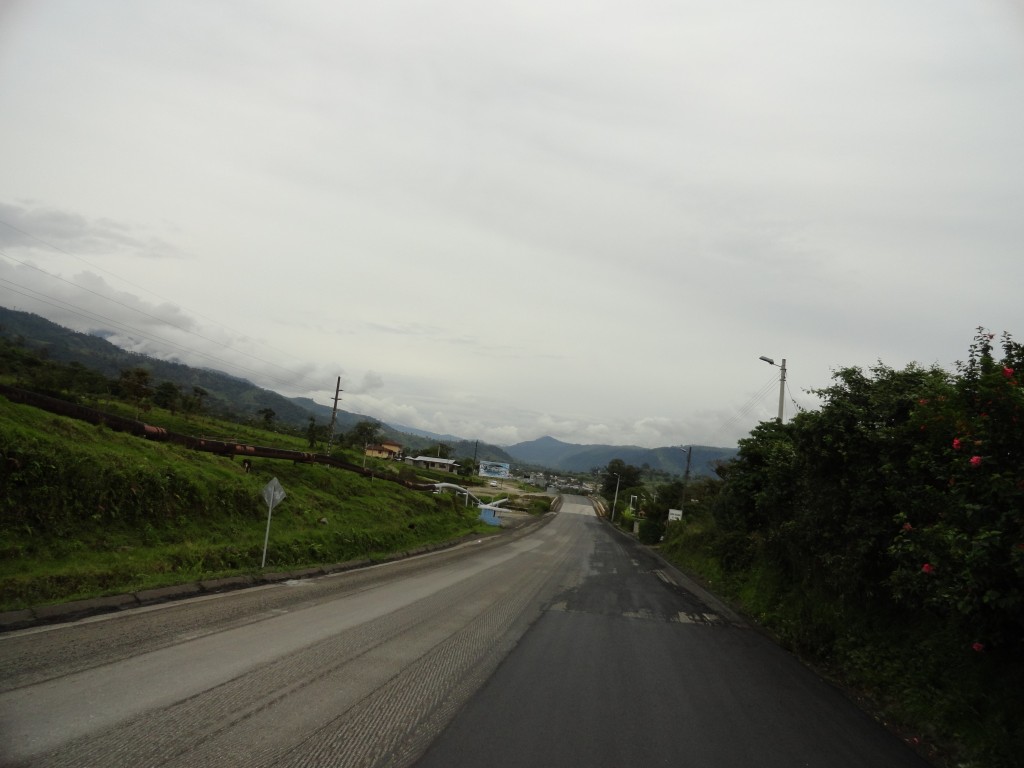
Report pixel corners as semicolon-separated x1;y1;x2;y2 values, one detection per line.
0;397;491;610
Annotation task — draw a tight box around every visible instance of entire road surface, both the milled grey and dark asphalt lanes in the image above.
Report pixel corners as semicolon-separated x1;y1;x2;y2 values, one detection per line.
0;497;926;768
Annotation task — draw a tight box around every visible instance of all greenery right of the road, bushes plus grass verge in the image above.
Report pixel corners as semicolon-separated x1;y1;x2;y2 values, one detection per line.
603;331;1024;768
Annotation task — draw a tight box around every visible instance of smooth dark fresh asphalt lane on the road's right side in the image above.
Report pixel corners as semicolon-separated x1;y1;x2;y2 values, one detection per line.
417;499;927;768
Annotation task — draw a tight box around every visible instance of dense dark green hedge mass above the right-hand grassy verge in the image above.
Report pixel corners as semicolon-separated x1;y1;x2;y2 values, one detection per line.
715;331;1024;647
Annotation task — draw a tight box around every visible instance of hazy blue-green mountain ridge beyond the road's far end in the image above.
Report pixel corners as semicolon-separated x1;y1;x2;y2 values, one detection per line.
505;437;736;476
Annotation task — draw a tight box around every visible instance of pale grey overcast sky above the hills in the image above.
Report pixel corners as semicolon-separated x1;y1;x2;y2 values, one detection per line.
0;0;1024;446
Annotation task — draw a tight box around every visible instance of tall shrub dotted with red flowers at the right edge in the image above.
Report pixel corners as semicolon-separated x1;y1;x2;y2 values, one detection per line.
890;330;1024;645
